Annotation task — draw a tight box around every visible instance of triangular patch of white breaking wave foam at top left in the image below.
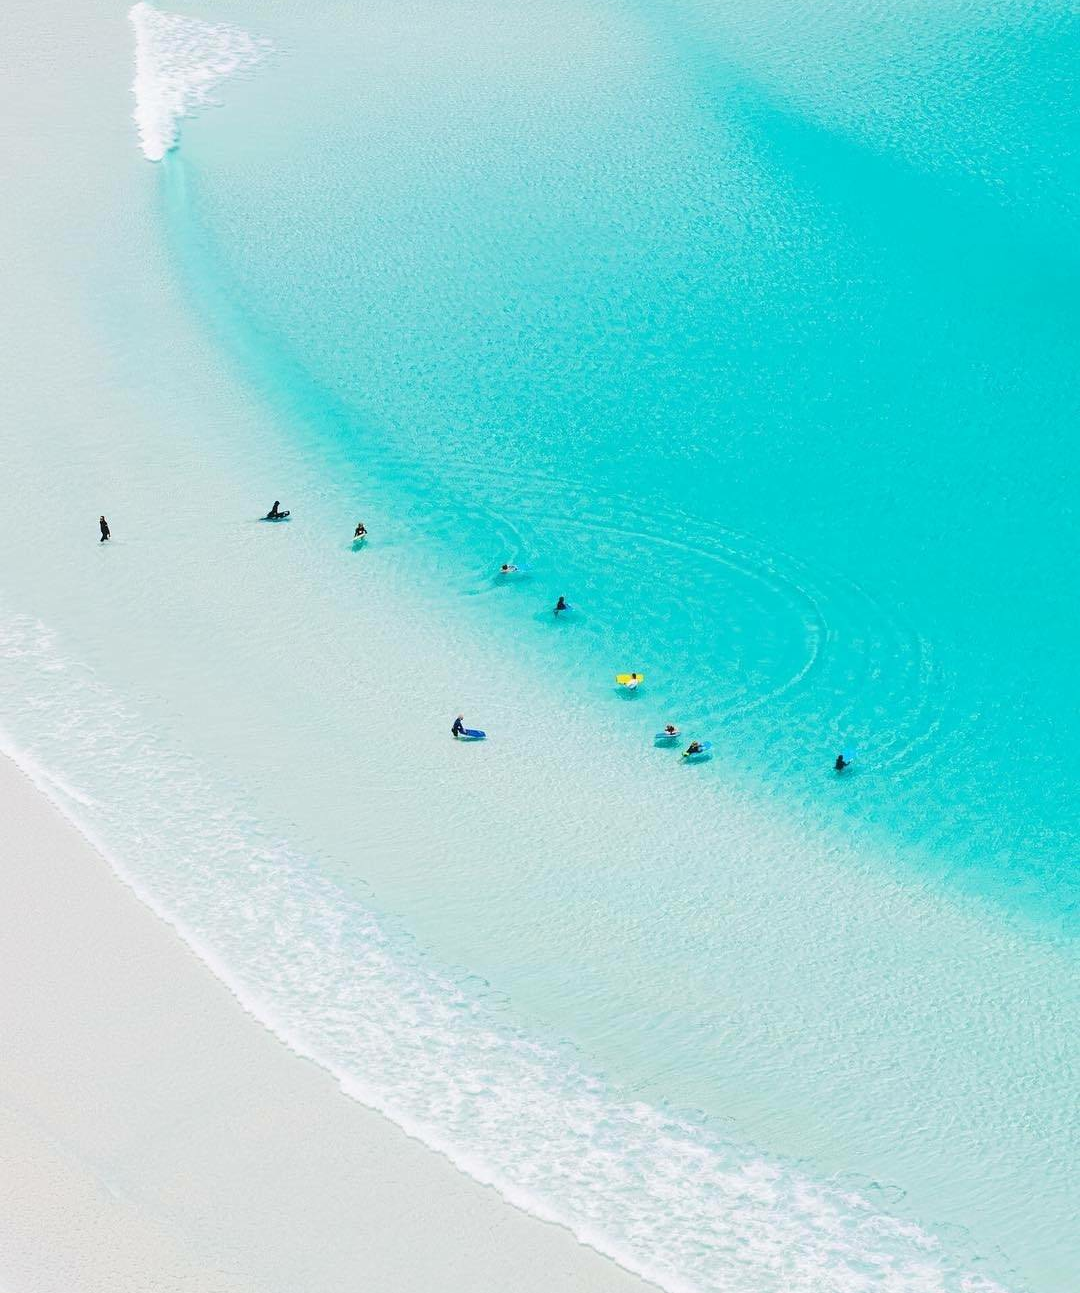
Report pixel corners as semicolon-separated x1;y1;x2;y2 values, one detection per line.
128;3;272;162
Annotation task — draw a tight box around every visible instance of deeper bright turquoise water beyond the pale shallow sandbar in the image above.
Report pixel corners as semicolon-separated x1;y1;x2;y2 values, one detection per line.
169;4;1080;924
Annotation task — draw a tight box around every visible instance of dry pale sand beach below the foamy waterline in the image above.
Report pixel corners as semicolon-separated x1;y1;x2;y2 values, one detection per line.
0;755;653;1293
